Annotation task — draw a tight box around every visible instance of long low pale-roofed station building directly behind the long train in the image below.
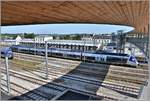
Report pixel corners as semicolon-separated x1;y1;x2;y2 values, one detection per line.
20;40;100;51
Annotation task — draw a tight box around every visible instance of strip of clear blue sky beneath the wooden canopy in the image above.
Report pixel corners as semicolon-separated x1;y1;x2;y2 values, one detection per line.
1;24;133;34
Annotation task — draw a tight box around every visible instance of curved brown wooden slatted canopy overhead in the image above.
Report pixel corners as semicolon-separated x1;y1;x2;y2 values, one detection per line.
1;0;149;33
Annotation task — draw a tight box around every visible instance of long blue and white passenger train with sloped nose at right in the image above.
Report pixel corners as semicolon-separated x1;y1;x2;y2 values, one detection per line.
11;45;138;67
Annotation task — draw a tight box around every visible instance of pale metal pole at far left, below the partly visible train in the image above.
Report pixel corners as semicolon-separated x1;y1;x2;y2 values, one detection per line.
5;56;10;94
